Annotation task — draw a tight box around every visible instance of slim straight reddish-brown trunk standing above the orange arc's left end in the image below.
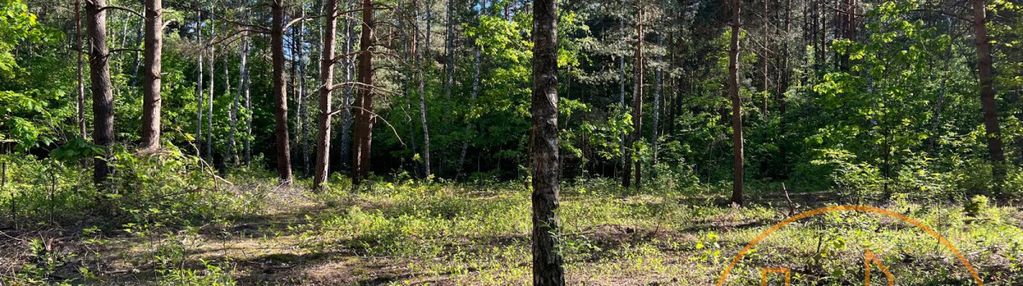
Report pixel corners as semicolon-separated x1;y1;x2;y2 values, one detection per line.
728;0;744;205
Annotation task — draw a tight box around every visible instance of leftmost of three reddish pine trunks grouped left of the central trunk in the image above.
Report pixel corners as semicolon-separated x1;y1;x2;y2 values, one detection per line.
270;0;292;184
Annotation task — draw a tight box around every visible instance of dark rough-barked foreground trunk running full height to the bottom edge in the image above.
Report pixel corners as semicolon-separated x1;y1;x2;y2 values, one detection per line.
530;0;565;286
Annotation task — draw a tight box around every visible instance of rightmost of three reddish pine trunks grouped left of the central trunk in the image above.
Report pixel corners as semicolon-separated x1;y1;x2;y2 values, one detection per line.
352;0;376;185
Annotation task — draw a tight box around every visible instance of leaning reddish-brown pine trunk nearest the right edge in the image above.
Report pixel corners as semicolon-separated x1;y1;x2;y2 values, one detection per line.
971;0;1006;192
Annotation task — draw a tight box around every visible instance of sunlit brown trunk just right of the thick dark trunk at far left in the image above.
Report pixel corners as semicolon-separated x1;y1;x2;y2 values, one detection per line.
141;0;164;151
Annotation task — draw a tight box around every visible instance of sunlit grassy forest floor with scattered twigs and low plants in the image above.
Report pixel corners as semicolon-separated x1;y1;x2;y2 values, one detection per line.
0;178;1023;285
